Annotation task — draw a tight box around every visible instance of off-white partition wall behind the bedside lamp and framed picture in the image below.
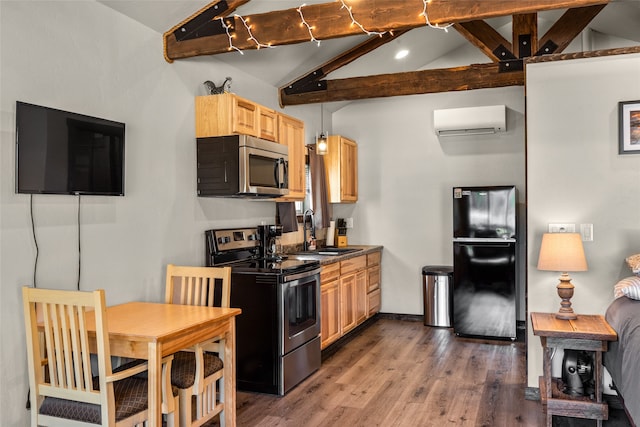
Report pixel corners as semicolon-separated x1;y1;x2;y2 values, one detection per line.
526;55;640;387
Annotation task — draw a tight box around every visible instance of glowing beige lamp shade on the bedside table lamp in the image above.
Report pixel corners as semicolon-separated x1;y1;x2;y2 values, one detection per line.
538;233;587;272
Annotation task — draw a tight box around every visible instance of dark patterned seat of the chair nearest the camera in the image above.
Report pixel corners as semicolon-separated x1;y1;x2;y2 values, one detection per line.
40;377;148;424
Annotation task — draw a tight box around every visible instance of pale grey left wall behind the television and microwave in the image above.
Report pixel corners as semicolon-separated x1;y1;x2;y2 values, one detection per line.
0;0;320;426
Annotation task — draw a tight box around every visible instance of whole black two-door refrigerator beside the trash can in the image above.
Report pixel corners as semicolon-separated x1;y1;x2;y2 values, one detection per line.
453;185;517;340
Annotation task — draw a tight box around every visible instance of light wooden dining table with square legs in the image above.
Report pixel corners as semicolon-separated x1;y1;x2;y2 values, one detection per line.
87;302;241;427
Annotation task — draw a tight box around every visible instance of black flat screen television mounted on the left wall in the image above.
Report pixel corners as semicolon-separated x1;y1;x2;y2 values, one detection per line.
16;101;125;196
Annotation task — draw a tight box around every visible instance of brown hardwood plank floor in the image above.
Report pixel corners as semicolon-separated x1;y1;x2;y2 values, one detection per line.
215;319;544;427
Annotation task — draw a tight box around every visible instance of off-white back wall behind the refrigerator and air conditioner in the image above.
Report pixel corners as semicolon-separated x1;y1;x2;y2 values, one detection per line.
333;87;525;317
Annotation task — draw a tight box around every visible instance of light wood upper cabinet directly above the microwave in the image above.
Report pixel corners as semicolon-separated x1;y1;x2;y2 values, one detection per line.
196;93;278;141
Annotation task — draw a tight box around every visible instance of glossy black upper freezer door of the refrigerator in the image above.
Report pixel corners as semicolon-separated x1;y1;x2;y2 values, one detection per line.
453;186;517;239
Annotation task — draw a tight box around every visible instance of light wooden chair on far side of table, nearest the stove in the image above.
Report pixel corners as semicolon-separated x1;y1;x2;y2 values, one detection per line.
165;264;231;427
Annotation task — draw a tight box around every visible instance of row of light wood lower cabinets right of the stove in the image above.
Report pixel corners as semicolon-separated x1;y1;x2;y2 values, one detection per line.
320;252;381;348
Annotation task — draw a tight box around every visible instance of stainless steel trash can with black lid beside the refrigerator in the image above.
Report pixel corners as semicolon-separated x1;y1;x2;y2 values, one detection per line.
422;265;453;328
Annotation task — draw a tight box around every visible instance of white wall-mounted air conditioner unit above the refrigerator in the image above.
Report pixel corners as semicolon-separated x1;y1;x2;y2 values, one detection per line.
433;105;507;136
